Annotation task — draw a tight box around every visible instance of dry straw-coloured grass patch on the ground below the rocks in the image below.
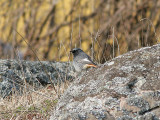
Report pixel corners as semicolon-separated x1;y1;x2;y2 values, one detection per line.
0;84;67;120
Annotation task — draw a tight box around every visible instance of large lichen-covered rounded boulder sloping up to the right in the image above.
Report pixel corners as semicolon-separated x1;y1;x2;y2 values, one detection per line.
50;44;160;120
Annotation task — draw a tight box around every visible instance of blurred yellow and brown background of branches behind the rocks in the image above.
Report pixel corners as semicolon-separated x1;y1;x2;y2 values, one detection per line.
0;0;160;63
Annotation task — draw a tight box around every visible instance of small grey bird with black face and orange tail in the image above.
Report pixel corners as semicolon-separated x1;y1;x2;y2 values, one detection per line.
70;48;97;72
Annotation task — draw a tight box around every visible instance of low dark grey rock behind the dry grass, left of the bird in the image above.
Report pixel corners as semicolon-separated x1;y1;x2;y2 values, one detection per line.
0;60;74;98
